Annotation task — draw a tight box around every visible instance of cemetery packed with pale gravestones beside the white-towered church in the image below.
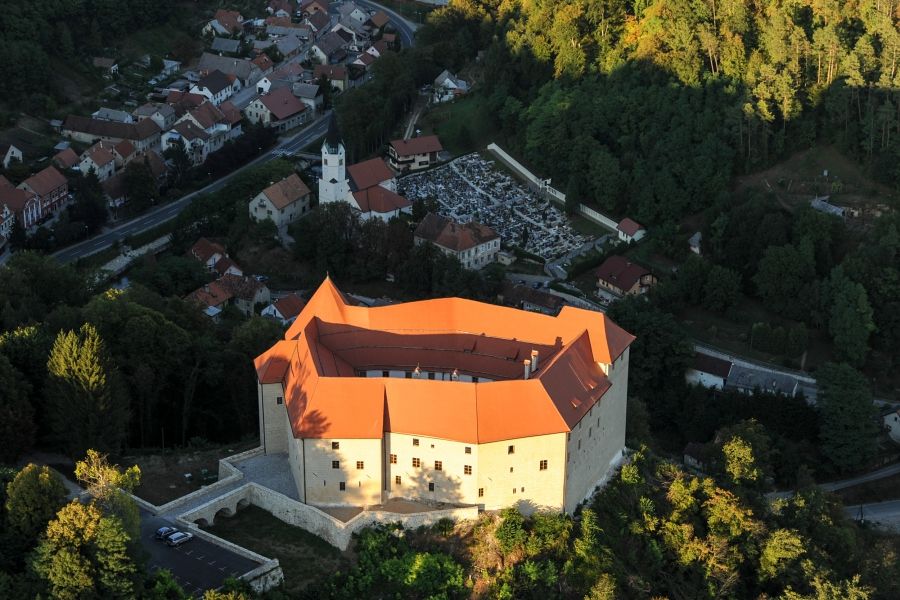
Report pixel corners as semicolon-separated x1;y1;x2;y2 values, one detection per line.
398;153;593;260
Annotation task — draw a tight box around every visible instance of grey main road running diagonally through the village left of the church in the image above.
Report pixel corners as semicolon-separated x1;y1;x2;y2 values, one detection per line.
53;112;329;263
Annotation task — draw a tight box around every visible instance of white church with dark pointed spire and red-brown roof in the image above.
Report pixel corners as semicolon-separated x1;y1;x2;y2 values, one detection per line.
319;114;412;221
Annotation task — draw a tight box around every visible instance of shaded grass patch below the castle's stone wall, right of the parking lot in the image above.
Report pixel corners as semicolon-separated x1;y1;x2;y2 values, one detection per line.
207;506;351;598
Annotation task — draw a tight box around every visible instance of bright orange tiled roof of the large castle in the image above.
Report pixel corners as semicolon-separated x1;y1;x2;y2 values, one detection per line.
255;278;634;443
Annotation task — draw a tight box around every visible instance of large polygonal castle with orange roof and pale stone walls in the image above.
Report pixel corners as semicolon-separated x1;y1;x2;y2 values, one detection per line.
255;278;634;513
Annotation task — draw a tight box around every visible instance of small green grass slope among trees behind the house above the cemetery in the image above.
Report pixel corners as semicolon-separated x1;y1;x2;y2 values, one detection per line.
418;94;496;156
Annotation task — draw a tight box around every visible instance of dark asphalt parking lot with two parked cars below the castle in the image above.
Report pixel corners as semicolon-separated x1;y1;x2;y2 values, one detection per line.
141;509;259;596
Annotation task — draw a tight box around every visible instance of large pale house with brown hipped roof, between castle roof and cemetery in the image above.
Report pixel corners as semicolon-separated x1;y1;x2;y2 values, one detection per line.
414;213;500;269
